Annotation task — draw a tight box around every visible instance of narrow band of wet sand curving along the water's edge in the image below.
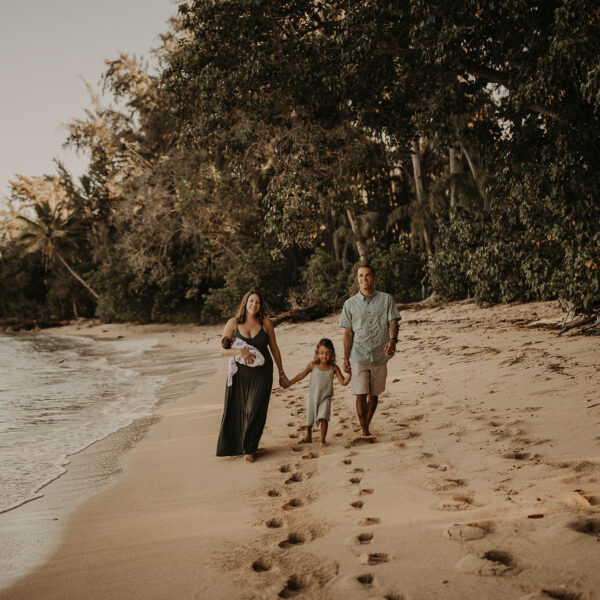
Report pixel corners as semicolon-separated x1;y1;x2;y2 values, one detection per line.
0;321;220;591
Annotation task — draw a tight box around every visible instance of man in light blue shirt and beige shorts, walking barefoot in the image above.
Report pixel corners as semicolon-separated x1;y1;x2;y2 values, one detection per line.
340;266;400;435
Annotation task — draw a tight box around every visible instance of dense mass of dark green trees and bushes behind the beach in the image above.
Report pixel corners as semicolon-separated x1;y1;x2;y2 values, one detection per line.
0;0;600;321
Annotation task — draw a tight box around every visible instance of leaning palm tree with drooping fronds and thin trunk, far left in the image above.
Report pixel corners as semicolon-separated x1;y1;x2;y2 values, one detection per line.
17;200;99;300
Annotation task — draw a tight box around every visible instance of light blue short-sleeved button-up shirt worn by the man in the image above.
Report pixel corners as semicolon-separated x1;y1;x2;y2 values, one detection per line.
340;291;400;365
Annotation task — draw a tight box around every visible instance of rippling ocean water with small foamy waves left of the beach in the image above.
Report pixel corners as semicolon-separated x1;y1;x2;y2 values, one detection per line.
0;334;206;512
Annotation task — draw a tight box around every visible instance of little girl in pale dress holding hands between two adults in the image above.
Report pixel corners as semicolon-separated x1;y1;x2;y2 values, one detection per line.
290;338;352;446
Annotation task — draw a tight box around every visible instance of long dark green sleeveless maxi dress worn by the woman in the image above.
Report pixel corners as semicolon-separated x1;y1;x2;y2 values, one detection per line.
217;329;273;456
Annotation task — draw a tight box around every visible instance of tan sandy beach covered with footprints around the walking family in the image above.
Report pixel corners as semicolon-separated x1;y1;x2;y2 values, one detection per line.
0;302;600;600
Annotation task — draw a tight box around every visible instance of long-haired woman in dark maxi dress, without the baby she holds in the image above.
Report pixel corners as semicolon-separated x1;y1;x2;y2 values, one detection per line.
217;290;289;462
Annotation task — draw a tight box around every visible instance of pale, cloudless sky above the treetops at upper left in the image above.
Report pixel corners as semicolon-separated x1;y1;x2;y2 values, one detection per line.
0;0;177;201
